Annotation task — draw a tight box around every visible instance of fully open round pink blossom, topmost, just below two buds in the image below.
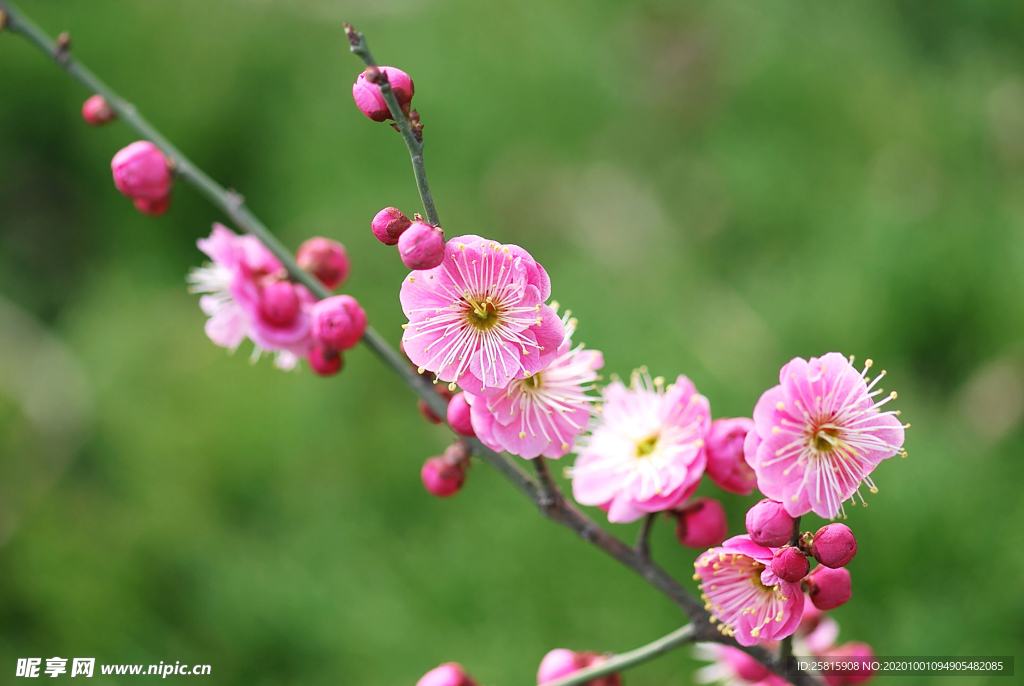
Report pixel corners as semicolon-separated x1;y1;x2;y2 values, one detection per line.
400;235;565;393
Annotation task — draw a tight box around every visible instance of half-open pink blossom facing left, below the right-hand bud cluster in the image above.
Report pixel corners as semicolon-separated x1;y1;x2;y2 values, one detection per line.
693;535;804;645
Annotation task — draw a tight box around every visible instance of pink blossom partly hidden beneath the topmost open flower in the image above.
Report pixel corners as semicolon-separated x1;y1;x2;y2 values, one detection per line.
466;312;604;460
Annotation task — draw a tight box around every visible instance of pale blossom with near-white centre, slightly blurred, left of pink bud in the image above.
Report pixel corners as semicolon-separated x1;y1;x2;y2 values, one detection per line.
570;369;711;522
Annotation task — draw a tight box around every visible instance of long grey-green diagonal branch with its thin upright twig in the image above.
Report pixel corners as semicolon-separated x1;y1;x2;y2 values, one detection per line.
0;6;818;686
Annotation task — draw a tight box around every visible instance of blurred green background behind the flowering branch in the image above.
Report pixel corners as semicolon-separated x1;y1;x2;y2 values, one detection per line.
0;0;1024;686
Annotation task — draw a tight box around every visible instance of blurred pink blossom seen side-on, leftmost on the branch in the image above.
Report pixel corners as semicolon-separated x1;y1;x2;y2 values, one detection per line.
188;224;315;369
